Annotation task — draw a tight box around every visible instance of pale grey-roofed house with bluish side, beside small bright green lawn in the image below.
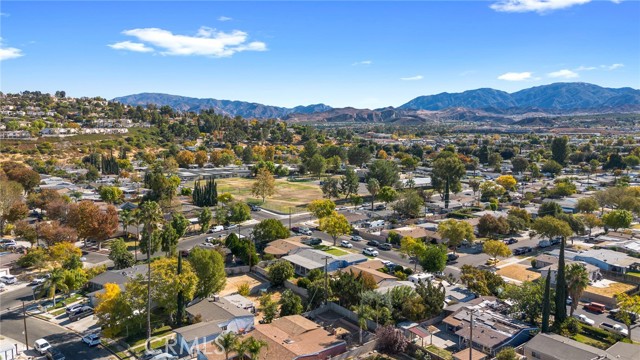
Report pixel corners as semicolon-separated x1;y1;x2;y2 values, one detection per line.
283;249;367;276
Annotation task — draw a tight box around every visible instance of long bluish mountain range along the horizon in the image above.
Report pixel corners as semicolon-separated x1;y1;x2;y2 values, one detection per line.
113;82;640;123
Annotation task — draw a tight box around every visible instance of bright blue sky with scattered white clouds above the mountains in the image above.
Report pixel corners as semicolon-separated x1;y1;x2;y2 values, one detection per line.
0;0;640;108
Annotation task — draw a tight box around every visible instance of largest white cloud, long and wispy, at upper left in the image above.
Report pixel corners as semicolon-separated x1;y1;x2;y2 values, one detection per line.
112;26;267;57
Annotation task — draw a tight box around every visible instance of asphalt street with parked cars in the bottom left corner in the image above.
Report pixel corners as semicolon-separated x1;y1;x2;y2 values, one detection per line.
0;309;112;360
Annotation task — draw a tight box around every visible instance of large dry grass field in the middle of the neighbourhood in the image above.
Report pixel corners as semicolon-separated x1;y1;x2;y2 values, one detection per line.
216;178;322;214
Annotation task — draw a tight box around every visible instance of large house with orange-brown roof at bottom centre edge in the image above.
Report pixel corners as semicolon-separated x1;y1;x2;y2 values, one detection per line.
207;315;347;360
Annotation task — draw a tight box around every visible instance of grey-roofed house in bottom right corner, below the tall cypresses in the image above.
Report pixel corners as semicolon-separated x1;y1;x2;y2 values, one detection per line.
523;334;640;360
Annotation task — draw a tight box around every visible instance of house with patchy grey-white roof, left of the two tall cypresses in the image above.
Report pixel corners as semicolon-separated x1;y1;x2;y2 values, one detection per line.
442;296;538;355
